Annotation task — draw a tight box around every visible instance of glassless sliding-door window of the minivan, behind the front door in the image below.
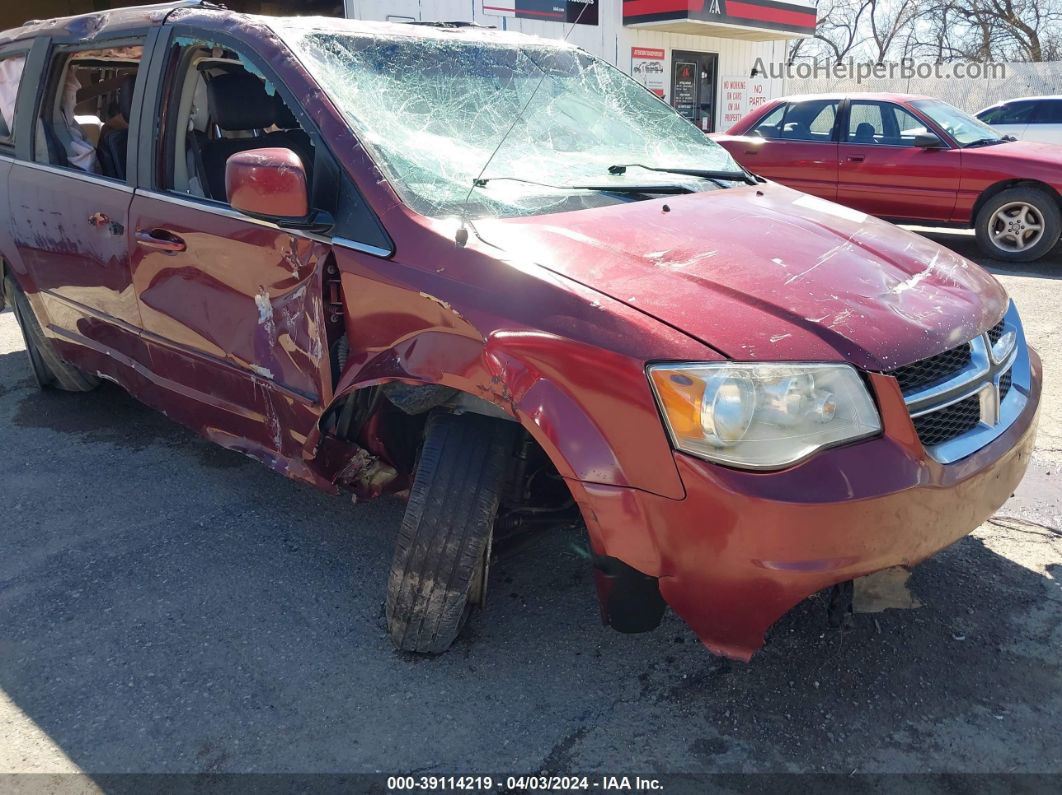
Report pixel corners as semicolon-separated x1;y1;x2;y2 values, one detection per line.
33;44;143;180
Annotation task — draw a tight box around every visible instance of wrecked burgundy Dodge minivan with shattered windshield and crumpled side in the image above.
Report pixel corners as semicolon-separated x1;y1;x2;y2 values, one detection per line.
0;2;1041;659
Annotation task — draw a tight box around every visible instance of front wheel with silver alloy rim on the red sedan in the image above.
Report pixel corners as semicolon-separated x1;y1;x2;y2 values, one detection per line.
975;188;1062;262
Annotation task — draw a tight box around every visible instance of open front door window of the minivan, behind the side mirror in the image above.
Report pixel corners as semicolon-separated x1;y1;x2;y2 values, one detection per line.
171;47;314;203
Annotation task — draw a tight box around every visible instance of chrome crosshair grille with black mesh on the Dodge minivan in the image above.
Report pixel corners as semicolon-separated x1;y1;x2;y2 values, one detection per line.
891;306;1031;464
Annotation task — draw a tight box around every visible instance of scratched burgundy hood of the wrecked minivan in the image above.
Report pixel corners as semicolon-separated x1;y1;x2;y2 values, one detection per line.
476;184;1007;370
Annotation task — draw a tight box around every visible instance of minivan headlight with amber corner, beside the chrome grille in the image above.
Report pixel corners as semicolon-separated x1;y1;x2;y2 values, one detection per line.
649;362;881;469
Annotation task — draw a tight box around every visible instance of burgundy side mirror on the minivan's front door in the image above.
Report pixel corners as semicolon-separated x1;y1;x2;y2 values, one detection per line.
225;148;311;226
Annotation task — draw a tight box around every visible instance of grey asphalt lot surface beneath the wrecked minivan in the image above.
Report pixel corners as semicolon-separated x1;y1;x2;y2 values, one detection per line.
0;231;1062;774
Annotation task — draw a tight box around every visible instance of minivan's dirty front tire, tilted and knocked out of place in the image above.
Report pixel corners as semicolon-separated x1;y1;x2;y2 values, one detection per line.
387;414;518;654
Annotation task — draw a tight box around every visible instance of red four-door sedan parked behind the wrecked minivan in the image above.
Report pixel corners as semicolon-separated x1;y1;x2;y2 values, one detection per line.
713;93;1062;262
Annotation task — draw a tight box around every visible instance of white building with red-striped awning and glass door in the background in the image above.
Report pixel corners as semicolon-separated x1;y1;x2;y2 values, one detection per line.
344;0;816;132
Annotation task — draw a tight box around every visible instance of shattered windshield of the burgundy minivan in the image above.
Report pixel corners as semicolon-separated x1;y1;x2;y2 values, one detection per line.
281;30;740;218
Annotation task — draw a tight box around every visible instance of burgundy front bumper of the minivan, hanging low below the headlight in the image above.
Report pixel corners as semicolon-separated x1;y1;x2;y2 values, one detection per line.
570;349;1041;660
